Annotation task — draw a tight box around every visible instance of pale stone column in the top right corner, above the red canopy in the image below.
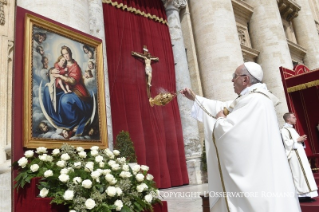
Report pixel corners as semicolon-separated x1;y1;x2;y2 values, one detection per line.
293;0;319;69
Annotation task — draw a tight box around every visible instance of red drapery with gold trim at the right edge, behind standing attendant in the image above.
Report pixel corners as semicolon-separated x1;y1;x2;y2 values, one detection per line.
280;65;319;156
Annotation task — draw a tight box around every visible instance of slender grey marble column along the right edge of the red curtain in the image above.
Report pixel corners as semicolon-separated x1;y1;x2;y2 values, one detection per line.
163;0;202;184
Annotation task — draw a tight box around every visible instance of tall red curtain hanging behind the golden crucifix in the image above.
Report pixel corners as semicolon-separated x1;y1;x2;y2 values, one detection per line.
103;0;188;188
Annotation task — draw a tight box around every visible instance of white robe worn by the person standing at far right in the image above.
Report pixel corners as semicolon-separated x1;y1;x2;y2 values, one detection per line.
281;124;318;197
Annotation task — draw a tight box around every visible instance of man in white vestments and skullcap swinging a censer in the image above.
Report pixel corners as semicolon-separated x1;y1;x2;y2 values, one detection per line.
181;62;300;212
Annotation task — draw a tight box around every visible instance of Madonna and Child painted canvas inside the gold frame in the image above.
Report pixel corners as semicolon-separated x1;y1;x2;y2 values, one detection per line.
32;26;100;140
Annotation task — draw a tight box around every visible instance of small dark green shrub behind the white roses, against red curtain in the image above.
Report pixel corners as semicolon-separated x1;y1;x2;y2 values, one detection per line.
114;131;137;163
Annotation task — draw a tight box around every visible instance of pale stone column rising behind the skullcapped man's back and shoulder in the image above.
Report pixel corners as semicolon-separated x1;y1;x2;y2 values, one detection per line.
246;0;293;124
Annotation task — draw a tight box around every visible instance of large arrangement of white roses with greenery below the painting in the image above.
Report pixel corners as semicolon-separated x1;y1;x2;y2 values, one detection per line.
14;144;161;212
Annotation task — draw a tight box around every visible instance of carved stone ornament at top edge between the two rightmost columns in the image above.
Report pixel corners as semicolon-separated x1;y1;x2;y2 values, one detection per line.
277;0;301;21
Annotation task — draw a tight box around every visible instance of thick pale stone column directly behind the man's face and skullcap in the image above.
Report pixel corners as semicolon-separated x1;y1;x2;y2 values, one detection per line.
189;0;243;100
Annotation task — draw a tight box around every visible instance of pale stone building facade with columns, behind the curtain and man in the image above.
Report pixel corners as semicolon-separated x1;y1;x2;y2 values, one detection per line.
0;0;319;207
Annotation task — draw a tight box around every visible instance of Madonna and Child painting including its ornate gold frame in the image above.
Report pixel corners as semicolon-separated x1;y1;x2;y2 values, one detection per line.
23;14;107;149
